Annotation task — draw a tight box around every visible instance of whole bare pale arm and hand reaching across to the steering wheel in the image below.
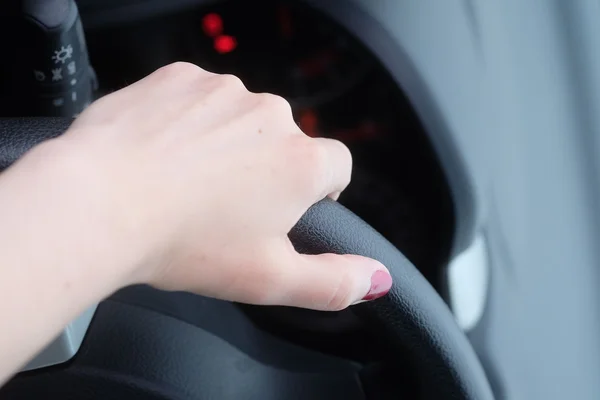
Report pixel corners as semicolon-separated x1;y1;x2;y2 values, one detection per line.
0;63;391;385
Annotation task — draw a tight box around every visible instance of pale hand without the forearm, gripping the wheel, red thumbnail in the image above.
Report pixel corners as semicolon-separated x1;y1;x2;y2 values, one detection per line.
49;63;391;310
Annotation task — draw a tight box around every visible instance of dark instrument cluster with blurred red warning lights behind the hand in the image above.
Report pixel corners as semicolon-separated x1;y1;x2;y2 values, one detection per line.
81;0;454;291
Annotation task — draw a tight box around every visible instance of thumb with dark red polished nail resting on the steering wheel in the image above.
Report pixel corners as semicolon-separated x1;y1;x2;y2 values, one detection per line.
270;251;392;311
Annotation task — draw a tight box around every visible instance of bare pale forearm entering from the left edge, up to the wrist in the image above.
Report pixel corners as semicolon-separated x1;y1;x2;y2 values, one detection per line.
0;141;138;384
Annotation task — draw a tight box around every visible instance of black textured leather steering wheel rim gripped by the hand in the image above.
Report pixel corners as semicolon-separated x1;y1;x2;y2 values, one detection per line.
0;118;494;400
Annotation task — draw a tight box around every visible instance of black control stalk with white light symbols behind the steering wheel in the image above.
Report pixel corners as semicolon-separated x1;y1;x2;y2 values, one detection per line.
0;0;96;117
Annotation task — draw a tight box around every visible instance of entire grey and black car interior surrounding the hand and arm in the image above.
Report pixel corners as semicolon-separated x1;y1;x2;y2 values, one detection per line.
0;0;600;400
